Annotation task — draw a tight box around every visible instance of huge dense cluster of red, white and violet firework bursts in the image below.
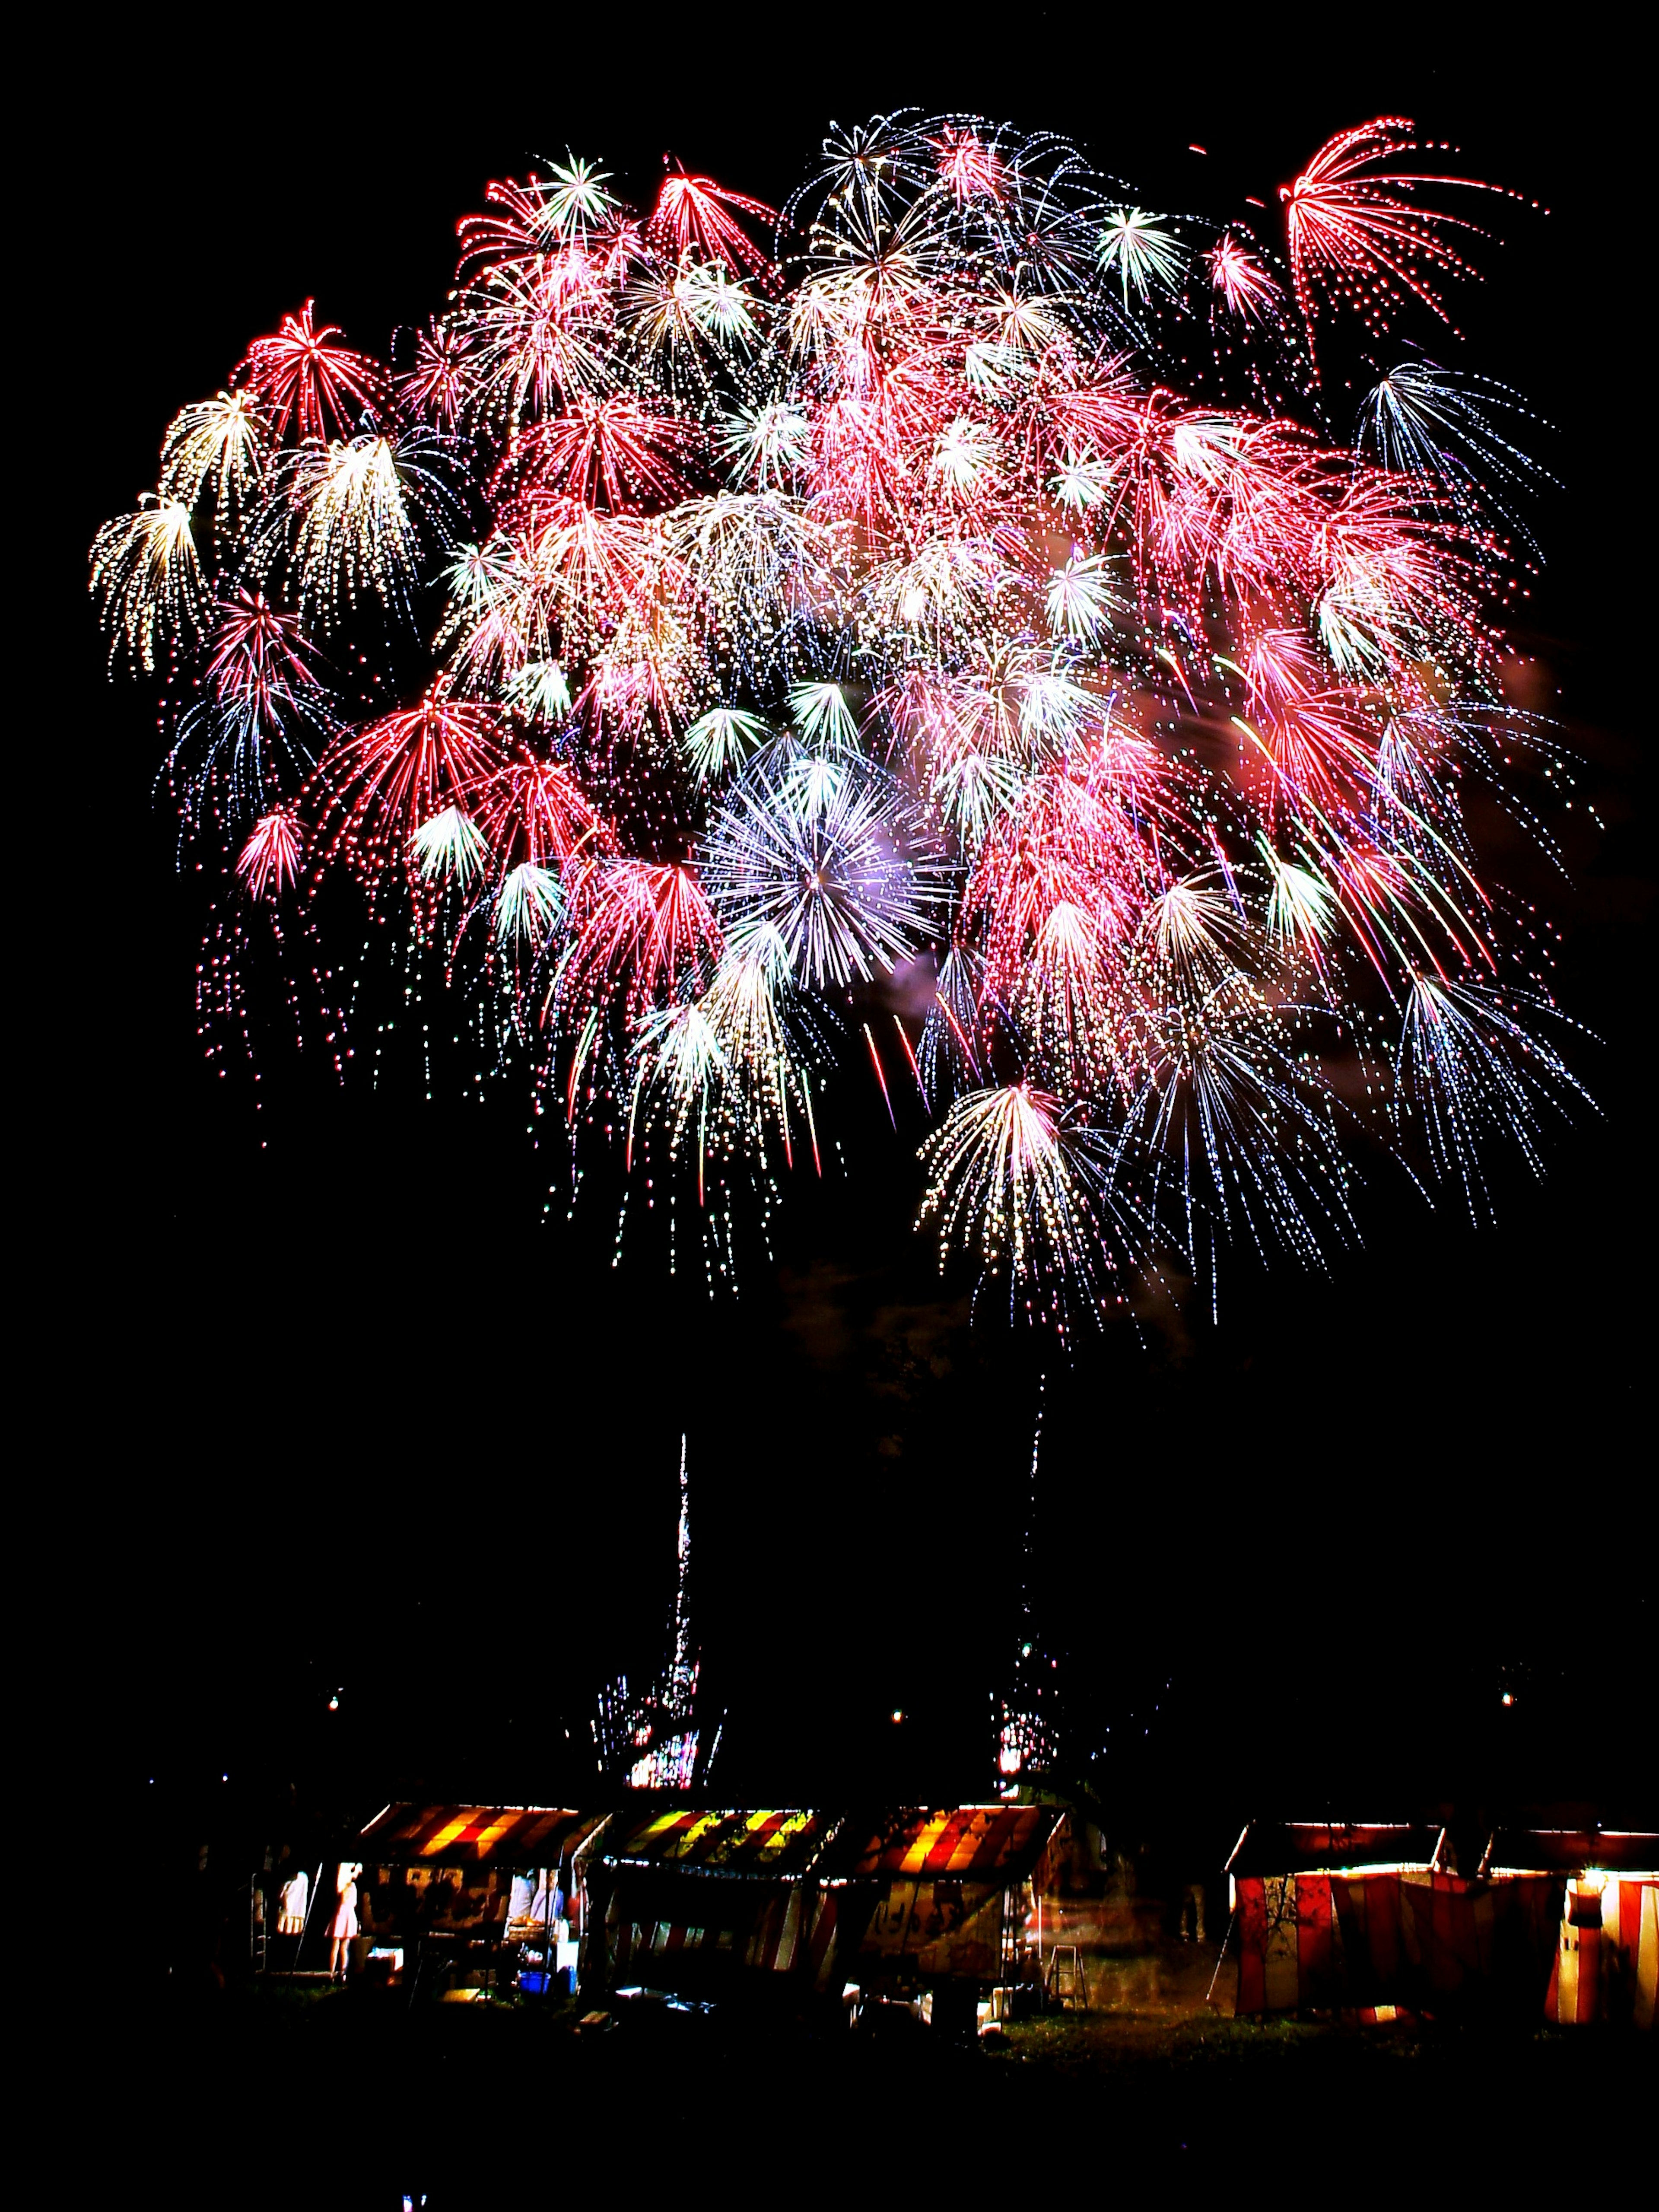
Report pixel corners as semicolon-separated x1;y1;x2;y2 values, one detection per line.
91;113;1577;1330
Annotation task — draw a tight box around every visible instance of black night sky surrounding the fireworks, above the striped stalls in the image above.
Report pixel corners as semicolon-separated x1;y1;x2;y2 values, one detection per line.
45;9;1655;1858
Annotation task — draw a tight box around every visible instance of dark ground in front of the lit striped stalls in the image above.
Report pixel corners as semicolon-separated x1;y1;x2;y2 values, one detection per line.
100;1940;1659;2212
